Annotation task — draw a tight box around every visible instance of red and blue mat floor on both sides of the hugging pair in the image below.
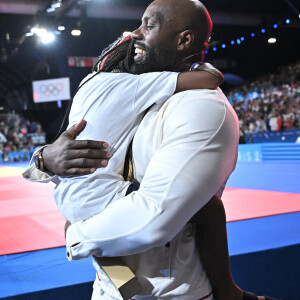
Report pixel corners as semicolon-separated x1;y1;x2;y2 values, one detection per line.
0;162;300;300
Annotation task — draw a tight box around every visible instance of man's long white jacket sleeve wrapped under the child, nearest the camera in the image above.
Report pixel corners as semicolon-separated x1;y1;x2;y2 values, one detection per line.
66;91;239;260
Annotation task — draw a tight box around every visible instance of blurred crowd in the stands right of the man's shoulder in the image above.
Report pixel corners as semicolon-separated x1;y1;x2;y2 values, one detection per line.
228;61;300;135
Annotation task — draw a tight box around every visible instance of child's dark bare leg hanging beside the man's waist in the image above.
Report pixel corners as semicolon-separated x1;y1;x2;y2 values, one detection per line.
194;196;242;300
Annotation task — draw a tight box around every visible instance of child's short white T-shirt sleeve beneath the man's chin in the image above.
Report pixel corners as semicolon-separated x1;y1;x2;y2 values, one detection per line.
134;72;178;114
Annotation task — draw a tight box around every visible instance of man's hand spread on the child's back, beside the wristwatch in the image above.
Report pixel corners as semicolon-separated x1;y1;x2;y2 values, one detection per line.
43;120;111;176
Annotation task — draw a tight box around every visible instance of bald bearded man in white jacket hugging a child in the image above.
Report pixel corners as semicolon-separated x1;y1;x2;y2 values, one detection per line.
26;0;278;300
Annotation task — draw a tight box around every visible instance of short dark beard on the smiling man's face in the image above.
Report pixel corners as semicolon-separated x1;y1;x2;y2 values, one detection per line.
130;43;174;74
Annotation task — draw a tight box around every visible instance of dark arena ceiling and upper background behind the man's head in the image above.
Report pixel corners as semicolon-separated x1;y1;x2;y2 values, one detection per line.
0;0;300;141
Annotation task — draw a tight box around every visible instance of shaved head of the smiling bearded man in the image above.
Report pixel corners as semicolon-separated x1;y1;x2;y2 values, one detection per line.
131;0;212;73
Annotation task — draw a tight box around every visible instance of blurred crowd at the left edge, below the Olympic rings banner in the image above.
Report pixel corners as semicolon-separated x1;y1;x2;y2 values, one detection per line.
0;113;43;162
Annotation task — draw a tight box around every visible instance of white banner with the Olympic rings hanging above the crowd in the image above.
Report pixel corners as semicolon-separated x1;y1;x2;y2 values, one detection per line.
32;77;71;103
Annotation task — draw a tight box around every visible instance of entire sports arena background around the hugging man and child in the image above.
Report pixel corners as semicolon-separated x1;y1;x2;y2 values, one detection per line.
0;0;300;300
